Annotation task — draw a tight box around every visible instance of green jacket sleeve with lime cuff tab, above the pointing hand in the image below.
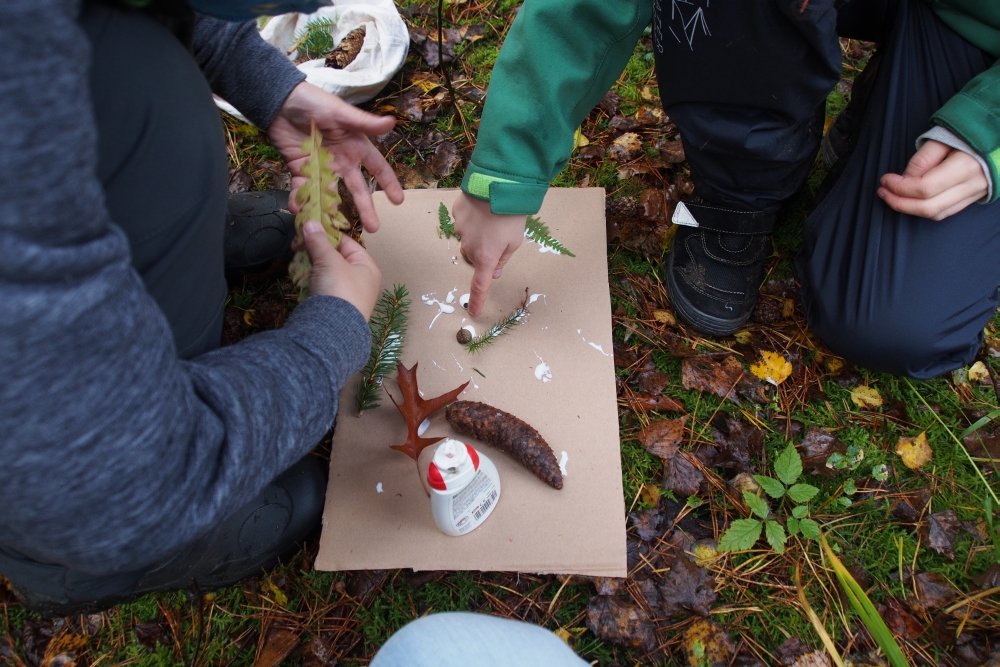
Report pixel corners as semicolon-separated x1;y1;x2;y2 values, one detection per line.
462;0;653;215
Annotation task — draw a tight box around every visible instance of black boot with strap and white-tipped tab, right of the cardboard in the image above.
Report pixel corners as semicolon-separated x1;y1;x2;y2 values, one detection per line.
667;199;776;336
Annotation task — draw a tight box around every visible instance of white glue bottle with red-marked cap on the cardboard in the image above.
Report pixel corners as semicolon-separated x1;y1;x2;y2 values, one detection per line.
427;438;500;537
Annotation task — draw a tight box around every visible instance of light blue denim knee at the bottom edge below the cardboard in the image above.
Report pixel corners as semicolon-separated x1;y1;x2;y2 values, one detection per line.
371;612;589;667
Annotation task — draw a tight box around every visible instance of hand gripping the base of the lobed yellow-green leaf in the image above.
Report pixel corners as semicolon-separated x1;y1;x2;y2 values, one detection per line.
302;220;382;320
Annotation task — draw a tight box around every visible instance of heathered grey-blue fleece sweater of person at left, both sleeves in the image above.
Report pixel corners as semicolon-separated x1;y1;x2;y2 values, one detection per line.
0;0;369;574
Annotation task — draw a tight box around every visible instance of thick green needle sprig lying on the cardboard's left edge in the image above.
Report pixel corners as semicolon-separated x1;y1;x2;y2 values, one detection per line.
358;285;410;417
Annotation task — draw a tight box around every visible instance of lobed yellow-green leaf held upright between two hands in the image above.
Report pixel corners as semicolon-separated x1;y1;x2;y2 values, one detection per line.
288;120;351;301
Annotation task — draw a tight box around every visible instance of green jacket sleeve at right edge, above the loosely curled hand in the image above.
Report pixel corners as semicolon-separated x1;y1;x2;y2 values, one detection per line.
931;60;1000;203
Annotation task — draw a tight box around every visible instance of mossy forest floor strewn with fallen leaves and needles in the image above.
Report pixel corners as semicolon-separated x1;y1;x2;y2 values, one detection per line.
0;0;1000;667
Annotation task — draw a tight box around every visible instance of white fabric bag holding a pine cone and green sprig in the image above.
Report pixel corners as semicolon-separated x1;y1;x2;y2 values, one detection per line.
215;0;410;120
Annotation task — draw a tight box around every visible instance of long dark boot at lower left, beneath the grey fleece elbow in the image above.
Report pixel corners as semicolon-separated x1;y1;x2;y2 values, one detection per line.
0;456;327;616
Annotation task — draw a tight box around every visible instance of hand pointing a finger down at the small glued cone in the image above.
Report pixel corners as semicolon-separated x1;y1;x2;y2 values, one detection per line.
452;192;527;317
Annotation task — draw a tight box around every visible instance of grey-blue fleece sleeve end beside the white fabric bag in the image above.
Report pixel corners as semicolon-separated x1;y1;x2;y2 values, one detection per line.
191;15;306;129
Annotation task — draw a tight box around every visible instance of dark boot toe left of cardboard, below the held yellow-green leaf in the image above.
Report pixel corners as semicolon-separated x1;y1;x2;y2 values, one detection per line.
224;190;295;269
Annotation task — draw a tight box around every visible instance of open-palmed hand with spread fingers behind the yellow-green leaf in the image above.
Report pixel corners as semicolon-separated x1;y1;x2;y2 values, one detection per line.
267;81;403;232
